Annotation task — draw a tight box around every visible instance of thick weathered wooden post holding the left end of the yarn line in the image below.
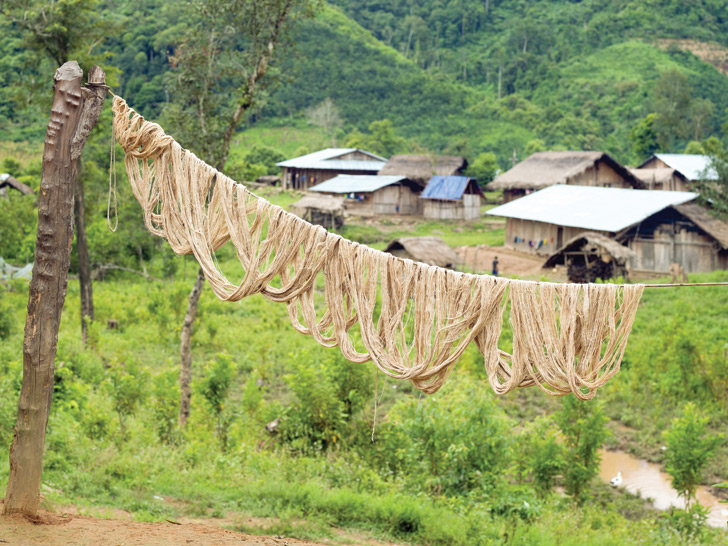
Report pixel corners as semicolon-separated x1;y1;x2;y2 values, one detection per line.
3;61;105;516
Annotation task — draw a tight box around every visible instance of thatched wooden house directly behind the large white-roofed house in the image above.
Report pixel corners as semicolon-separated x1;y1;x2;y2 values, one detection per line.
486;152;643;203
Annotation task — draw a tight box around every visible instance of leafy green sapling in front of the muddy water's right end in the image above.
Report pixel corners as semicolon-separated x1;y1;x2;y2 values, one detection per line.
663;402;723;508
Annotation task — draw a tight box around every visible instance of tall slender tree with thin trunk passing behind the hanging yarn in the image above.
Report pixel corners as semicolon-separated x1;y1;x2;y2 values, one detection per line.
164;0;312;426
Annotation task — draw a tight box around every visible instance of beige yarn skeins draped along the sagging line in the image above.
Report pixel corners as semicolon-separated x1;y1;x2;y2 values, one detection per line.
113;97;644;399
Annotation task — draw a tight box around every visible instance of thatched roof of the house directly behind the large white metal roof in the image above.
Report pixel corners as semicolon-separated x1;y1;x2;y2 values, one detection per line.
486;152;644;190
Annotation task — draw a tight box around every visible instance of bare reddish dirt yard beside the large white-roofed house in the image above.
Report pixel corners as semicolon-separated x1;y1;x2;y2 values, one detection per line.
455;245;566;280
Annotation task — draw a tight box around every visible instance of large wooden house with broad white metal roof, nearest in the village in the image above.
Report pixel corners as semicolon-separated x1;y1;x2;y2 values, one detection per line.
487;185;728;274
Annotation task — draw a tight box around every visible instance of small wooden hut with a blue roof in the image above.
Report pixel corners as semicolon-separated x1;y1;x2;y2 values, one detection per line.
422;176;485;220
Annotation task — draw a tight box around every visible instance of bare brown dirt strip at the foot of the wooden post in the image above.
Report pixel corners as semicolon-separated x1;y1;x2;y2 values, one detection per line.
0;507;404;546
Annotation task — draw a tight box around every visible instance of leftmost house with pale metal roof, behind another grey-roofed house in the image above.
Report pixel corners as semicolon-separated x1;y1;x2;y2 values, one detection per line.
276;148;387;190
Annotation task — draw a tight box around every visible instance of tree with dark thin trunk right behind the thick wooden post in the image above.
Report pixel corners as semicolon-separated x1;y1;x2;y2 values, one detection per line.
0;0;112;343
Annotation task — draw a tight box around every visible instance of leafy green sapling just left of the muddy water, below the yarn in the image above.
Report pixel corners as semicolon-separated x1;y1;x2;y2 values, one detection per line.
556;394;607;503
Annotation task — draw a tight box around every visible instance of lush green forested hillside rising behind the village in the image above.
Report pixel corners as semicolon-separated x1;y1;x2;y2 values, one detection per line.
0;0;728;167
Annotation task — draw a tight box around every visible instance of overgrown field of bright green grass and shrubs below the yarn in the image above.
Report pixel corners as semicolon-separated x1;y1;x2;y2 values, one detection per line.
0;250;726;544
